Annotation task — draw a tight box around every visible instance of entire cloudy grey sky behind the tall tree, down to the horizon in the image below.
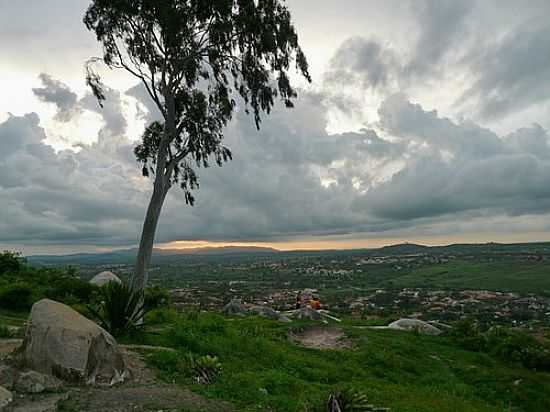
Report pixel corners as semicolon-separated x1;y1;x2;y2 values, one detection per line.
0;0;550;253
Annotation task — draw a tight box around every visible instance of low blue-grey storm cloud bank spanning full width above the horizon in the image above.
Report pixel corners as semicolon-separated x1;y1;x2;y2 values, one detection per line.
0;83;550;245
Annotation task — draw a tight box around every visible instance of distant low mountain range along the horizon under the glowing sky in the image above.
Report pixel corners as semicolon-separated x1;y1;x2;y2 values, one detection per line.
27;242;550;266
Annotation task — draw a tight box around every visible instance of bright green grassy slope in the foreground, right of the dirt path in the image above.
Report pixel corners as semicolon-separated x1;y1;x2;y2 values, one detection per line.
141;311;550;412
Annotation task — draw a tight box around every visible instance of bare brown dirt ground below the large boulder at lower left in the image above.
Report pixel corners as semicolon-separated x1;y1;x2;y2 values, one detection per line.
0;339;234;412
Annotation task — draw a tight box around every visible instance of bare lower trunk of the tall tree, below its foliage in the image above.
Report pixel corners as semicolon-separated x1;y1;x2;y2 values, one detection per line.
132;174;170;290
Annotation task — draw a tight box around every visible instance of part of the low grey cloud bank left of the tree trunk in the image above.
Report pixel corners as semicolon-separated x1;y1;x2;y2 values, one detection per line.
0;114;144;243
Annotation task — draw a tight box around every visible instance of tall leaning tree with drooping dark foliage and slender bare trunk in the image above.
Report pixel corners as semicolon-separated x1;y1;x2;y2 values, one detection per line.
84;0;311;290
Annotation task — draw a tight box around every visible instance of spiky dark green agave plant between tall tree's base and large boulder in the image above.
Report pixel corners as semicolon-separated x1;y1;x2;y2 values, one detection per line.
89;282;146;336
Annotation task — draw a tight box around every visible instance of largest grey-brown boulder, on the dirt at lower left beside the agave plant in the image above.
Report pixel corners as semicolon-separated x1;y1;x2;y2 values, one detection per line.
20;299;126;385
